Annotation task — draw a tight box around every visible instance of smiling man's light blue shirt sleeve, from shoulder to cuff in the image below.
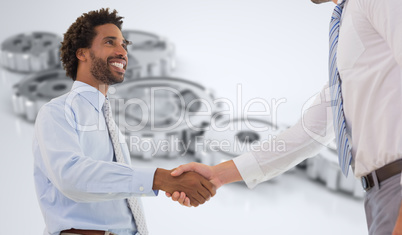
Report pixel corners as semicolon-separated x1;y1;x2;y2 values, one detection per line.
33;104;159;202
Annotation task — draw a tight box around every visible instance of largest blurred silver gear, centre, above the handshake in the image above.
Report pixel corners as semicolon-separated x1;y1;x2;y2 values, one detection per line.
109;77;217;159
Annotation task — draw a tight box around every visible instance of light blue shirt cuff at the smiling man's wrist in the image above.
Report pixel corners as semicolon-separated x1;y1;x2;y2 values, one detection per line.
132;167;159;197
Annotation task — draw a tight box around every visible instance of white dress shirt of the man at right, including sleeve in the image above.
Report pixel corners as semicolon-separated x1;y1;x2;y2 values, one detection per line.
234;0;402;188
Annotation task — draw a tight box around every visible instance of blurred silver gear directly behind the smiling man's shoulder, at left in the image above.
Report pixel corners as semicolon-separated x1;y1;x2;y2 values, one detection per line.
12;69;73;122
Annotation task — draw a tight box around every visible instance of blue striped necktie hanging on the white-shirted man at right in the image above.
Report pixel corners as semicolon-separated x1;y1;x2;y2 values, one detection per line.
329;1;352;176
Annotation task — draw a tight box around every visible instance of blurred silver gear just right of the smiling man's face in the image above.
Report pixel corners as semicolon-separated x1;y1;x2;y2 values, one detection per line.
122;30;176;80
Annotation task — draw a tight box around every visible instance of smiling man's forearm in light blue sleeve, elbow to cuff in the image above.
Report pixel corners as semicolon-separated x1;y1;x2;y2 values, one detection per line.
45;154;156;202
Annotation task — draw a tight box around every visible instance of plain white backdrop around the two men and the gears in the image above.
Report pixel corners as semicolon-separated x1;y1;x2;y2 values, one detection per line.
0;0;367;235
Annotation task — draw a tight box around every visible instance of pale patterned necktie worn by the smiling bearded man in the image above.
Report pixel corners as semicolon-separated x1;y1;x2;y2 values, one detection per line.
103;98;148;235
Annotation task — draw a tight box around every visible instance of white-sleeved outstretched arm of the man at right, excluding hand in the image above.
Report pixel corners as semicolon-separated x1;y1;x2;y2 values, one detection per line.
234;85;334;188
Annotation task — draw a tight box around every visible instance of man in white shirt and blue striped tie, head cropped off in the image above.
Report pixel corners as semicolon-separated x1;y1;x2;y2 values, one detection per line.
168;0;402;235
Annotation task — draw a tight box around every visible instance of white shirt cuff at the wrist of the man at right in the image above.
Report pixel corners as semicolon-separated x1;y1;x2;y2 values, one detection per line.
233;153;264;189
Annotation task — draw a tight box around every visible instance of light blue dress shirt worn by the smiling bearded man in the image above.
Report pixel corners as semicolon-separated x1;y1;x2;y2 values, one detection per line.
33;81;158;235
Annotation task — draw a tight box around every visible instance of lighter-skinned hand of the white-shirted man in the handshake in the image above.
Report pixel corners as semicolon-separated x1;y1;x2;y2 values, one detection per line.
166;161;242;207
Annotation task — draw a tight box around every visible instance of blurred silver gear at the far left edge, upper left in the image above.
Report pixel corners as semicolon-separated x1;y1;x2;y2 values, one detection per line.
0;32;62;73
